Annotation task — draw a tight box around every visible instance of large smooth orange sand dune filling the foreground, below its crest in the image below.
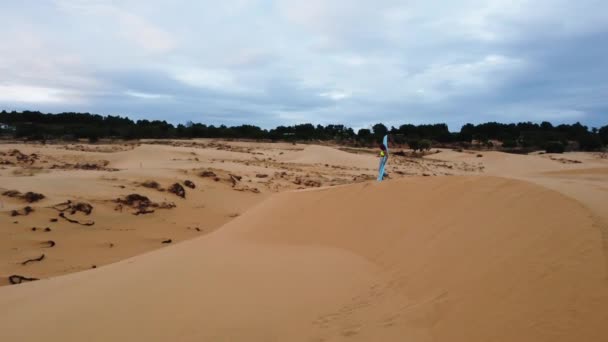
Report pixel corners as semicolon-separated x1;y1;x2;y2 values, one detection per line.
0;177;608;341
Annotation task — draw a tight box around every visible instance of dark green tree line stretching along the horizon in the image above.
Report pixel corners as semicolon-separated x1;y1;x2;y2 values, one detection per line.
0;111;608;152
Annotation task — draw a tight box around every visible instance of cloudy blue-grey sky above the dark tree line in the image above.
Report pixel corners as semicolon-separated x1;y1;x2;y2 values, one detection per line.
0;0;608;130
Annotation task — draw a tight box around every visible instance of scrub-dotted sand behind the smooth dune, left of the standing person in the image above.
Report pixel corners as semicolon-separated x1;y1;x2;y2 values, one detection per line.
0;139;384;286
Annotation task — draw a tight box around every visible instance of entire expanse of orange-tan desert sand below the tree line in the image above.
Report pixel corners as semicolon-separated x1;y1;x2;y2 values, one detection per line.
0;140;608;341
